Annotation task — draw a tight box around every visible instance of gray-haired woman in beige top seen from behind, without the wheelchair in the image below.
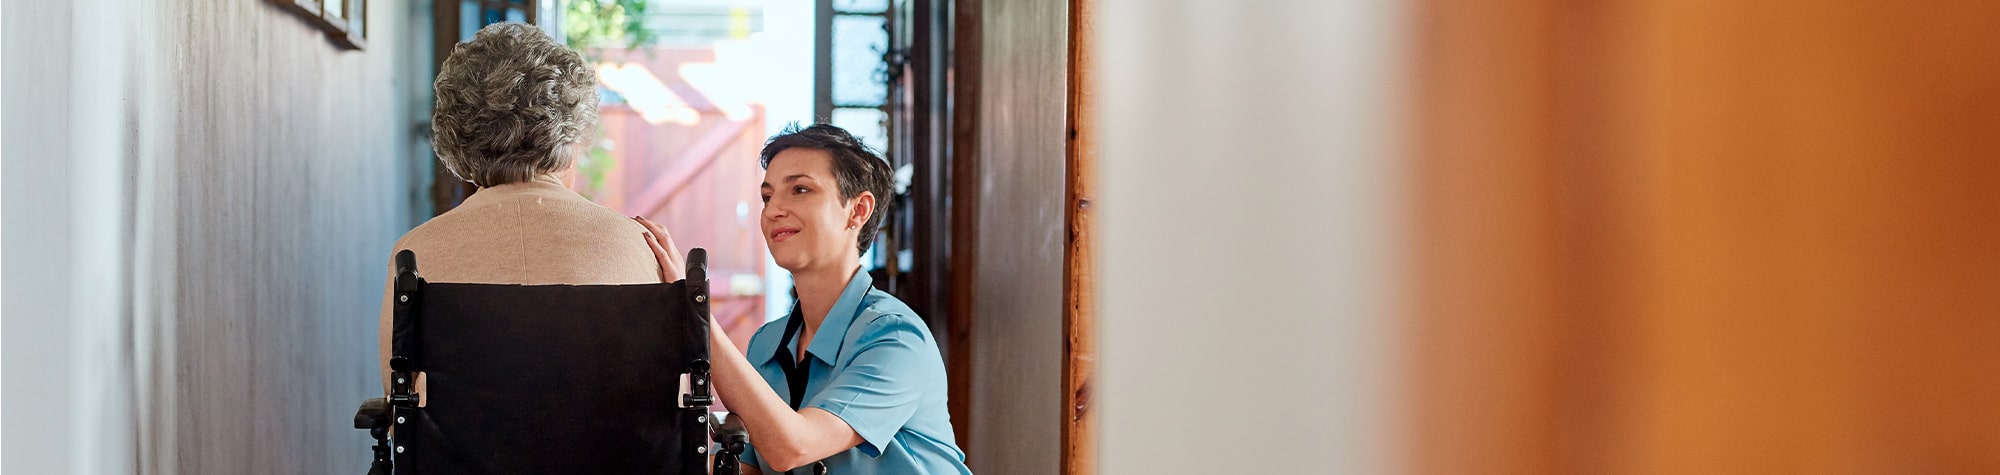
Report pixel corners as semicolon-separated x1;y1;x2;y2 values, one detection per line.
380;22;662;391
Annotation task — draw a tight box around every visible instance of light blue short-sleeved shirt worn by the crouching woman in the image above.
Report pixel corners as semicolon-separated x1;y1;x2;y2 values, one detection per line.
744;271;972;475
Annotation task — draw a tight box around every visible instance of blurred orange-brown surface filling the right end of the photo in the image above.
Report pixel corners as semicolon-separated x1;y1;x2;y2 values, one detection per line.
1410;0;2000;473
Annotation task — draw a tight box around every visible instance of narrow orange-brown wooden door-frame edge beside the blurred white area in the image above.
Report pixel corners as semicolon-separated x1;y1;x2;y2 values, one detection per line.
1062;0;1098;475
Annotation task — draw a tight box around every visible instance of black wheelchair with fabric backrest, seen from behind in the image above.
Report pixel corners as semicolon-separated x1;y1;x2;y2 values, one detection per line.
354;247;746;475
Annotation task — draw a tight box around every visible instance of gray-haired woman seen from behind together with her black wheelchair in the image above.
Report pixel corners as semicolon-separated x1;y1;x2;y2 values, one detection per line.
356;24;710;473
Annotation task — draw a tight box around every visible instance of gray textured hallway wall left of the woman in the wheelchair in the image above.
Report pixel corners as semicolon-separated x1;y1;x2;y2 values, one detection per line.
0;0;428;473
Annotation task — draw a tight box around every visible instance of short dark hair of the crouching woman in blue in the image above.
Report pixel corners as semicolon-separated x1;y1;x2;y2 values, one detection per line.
758;124;894;253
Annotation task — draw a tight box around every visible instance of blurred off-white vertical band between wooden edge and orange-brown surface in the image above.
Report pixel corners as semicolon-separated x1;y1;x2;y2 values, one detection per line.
1096;0;1410;473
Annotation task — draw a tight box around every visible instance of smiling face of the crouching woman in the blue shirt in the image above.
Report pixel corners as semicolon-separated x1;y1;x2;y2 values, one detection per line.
758;148;874;273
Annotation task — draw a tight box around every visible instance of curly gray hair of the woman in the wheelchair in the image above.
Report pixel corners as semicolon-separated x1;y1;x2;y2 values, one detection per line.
430;24;598;188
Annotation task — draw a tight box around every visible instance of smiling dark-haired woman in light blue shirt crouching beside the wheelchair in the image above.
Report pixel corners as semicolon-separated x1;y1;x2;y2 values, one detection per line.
642;124;972;475
